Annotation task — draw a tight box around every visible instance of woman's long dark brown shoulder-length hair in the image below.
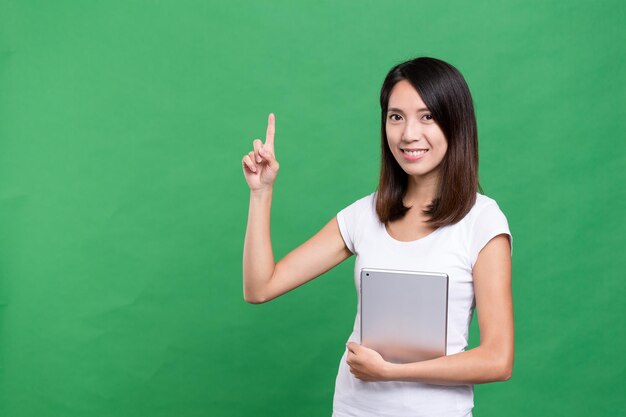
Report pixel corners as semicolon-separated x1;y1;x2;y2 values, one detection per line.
376;57;480;227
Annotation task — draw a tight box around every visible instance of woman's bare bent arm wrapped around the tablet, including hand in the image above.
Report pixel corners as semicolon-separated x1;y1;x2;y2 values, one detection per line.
347;235;514;385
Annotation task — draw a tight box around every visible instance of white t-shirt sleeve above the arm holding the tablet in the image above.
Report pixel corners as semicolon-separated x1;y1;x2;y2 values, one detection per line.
470;201;513;268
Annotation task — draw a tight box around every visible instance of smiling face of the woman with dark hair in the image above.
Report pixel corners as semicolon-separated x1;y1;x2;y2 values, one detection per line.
385;80;448;179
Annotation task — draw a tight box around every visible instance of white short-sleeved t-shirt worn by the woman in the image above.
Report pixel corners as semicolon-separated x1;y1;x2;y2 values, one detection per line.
333;193;511;417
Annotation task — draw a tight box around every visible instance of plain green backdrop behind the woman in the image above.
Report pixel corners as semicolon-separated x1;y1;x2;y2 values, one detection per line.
0;0;626;417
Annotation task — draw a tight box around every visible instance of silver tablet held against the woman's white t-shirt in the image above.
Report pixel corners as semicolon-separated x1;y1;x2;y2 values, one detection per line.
361;268;448;363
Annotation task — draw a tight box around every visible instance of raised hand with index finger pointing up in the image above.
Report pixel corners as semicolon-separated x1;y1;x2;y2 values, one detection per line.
242;113;279;191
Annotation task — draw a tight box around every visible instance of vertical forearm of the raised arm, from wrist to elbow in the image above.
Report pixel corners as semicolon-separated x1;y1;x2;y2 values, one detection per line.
243;188;275;303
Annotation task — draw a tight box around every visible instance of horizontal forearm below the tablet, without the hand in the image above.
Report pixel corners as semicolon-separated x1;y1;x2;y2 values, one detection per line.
385;346;513;385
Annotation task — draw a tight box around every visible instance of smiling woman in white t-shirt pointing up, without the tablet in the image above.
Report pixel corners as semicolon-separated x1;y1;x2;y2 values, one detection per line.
242;58;513;417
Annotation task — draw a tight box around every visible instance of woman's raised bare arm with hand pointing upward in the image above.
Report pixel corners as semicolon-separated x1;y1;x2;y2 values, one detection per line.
242;114;351;304
